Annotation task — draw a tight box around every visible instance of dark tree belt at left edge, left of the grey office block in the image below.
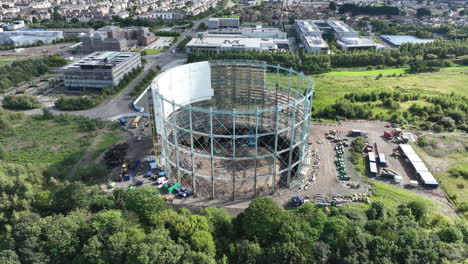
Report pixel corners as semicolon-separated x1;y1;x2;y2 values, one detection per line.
0;56;67;92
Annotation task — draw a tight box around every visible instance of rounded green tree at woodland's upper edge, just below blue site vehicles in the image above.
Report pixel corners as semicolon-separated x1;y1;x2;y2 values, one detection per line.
125;186;166;222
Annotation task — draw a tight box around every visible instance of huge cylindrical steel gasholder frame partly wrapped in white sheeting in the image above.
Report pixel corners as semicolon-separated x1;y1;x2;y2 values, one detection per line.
150;61;313;199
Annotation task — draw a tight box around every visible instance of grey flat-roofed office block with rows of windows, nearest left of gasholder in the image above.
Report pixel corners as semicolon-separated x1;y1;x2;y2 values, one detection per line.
62;52;141;89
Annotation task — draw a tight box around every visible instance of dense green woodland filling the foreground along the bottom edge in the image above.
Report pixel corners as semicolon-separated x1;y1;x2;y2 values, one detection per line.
0;180;468;264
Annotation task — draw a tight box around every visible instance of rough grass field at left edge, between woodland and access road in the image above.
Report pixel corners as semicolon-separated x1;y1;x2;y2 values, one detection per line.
0;114;122;180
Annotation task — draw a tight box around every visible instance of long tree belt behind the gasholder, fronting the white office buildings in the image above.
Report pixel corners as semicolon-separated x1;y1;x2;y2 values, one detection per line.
188;40;468;74
